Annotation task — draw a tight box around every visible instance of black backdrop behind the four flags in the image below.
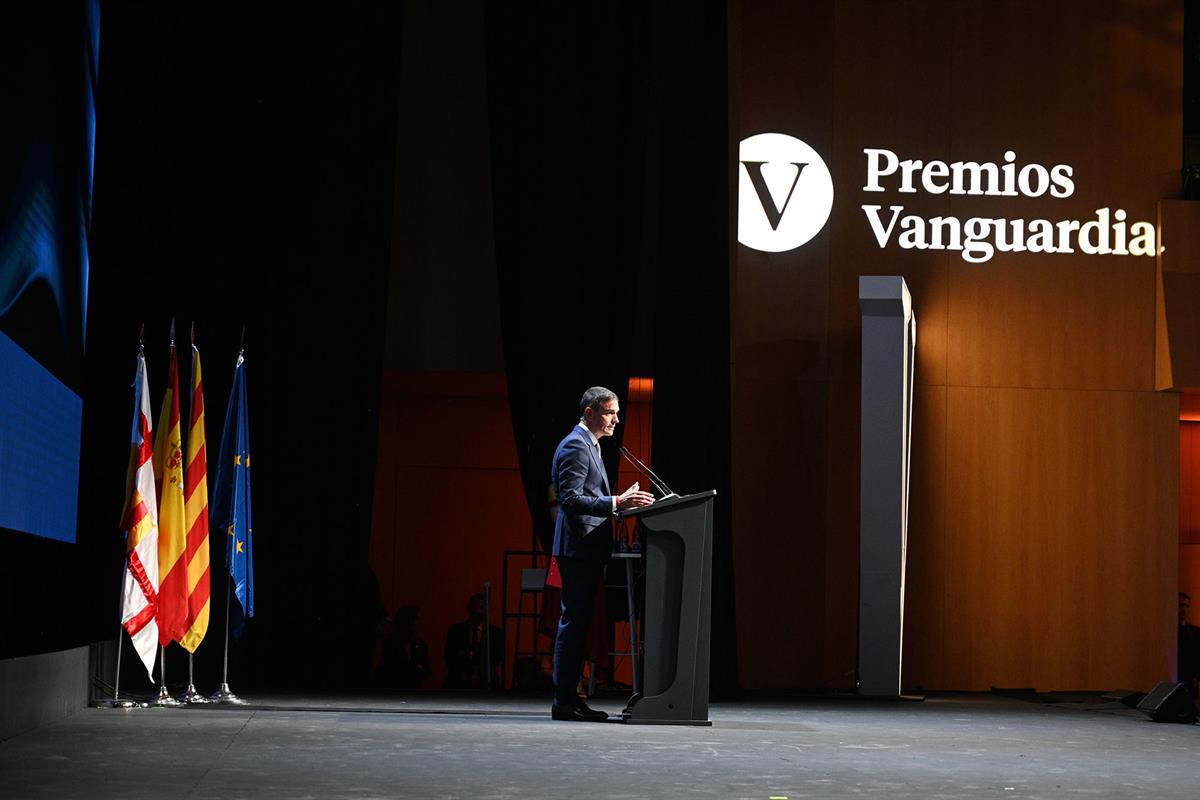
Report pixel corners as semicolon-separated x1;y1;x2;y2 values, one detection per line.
2;2;401;685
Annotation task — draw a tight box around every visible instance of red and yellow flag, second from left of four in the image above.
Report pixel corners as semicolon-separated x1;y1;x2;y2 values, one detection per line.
154;339;187;646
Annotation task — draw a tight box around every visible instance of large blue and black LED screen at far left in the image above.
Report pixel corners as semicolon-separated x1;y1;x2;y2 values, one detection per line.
0;0;100;542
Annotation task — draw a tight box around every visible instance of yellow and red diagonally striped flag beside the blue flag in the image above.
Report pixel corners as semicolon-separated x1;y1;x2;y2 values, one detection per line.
179;344;210;652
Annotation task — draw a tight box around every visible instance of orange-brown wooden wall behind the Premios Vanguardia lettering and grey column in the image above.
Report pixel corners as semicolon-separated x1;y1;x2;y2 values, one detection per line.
731;0;1182;690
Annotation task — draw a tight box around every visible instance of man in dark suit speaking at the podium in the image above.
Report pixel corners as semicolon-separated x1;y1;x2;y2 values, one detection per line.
551;386;654;722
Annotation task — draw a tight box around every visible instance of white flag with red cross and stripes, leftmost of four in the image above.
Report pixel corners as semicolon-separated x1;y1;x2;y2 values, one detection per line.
121;350;158;682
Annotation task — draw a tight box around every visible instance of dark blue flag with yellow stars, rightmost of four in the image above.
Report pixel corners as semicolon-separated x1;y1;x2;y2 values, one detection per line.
211;354;254;638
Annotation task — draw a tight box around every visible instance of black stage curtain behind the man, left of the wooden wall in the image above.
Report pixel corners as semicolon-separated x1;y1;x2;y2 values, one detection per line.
487;2;738;697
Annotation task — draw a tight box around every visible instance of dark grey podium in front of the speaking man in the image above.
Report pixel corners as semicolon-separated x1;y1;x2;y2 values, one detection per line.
618;491;716;726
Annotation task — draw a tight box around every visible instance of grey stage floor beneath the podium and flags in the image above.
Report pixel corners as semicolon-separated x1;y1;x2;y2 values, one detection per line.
0;692;1200;800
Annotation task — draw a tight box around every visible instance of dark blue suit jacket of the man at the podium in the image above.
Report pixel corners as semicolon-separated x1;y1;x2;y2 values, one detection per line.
551;425;612;561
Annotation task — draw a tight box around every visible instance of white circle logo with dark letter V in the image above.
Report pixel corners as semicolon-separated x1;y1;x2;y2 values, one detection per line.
738;133;833;253
